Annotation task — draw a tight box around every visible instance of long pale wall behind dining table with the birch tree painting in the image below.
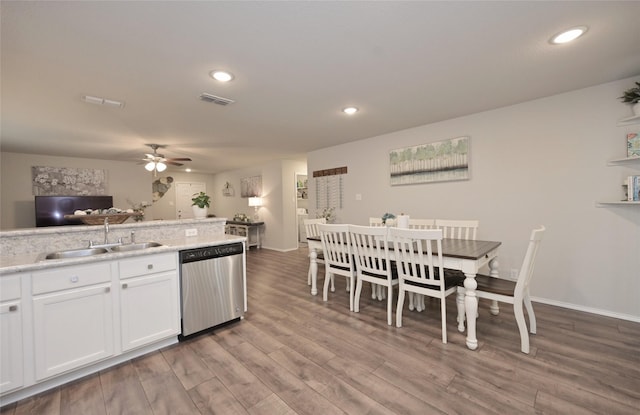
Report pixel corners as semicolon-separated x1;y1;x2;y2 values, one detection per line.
307;79;640;321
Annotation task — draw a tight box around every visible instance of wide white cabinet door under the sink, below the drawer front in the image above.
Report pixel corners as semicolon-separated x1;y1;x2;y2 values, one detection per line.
33;283;114;380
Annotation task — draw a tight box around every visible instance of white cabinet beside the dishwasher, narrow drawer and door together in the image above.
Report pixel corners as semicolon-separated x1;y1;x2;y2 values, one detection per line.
119;253;180;351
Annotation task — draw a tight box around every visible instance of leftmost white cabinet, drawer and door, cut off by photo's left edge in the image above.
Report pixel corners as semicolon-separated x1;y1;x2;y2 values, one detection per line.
0;275;24;392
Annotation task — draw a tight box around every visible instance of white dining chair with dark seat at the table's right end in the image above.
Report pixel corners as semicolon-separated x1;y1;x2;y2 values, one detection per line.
458;226;546;354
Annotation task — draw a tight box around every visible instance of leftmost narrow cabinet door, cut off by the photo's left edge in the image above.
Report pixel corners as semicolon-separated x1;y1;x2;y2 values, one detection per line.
0;301;23;392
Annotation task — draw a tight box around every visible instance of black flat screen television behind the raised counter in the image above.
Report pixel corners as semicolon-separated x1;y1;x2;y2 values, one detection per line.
35;196;113;227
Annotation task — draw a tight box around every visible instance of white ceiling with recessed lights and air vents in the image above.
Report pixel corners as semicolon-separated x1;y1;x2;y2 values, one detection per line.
0;0;640;173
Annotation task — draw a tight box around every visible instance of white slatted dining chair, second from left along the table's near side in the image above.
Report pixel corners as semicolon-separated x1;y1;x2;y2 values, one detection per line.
318;224;356;311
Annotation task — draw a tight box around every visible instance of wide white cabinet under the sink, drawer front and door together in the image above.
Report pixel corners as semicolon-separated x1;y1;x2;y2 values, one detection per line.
32;262;114;380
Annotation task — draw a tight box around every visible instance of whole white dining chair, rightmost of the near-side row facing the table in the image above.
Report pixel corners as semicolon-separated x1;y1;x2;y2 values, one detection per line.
389;228;460;343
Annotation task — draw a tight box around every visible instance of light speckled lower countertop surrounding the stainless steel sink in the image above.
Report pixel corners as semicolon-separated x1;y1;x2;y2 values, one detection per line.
0;234;246;276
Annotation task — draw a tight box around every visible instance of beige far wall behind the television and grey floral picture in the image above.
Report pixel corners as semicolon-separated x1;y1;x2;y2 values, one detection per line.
0;152;152;230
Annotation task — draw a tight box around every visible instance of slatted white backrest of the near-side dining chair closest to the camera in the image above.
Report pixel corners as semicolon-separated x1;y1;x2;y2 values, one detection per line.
389;228;444;290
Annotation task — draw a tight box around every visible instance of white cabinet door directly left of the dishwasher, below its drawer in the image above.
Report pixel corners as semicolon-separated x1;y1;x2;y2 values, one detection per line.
120;271;180;351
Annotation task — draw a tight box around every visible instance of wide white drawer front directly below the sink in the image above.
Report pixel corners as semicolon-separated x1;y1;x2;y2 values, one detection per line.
32;262;111;295
